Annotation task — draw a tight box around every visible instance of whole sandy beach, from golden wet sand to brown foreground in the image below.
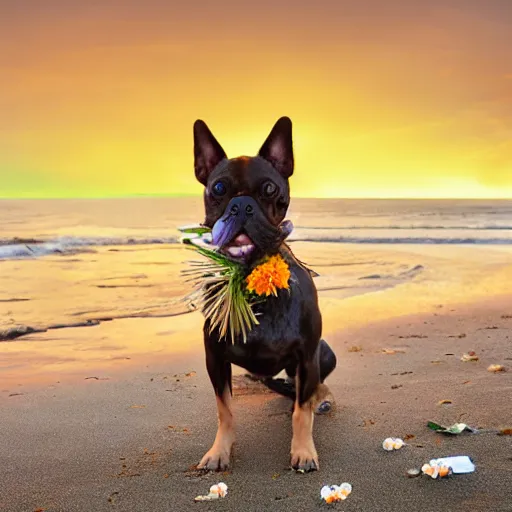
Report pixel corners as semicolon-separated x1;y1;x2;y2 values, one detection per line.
0;242;512;512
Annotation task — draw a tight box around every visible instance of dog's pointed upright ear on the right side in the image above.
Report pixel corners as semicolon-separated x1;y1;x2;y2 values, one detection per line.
258;117;293;179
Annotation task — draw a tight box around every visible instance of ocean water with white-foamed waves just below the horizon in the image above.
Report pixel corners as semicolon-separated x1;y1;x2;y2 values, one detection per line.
0;198;512;260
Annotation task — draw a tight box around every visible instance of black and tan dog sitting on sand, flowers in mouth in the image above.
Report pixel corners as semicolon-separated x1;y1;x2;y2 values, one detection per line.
193;117;336;472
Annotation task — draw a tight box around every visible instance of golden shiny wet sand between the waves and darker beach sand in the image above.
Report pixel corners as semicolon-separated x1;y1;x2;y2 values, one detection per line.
0;238;512;387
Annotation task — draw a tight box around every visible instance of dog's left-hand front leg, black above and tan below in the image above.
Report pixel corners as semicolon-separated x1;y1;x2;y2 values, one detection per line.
197;332;235;470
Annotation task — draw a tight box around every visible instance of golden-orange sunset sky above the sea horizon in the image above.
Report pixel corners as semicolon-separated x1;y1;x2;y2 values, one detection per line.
0;0;512;198
